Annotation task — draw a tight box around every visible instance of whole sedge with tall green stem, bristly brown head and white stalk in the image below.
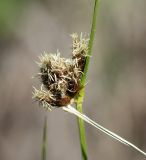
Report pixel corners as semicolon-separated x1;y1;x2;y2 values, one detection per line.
33;0;146;160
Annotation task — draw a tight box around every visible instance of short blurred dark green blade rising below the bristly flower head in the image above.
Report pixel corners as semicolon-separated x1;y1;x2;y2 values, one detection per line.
41;117;47;160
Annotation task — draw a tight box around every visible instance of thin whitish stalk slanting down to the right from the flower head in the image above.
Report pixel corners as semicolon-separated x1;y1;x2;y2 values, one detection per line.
63;105;146;156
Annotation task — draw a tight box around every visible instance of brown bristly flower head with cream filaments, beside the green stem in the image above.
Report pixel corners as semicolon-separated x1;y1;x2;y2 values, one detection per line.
33;34;88;108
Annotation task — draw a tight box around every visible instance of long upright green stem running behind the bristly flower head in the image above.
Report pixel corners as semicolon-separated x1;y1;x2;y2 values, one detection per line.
76;0;99;160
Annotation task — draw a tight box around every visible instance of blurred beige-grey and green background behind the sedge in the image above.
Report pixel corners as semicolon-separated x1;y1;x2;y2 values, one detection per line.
0;0;146;160
